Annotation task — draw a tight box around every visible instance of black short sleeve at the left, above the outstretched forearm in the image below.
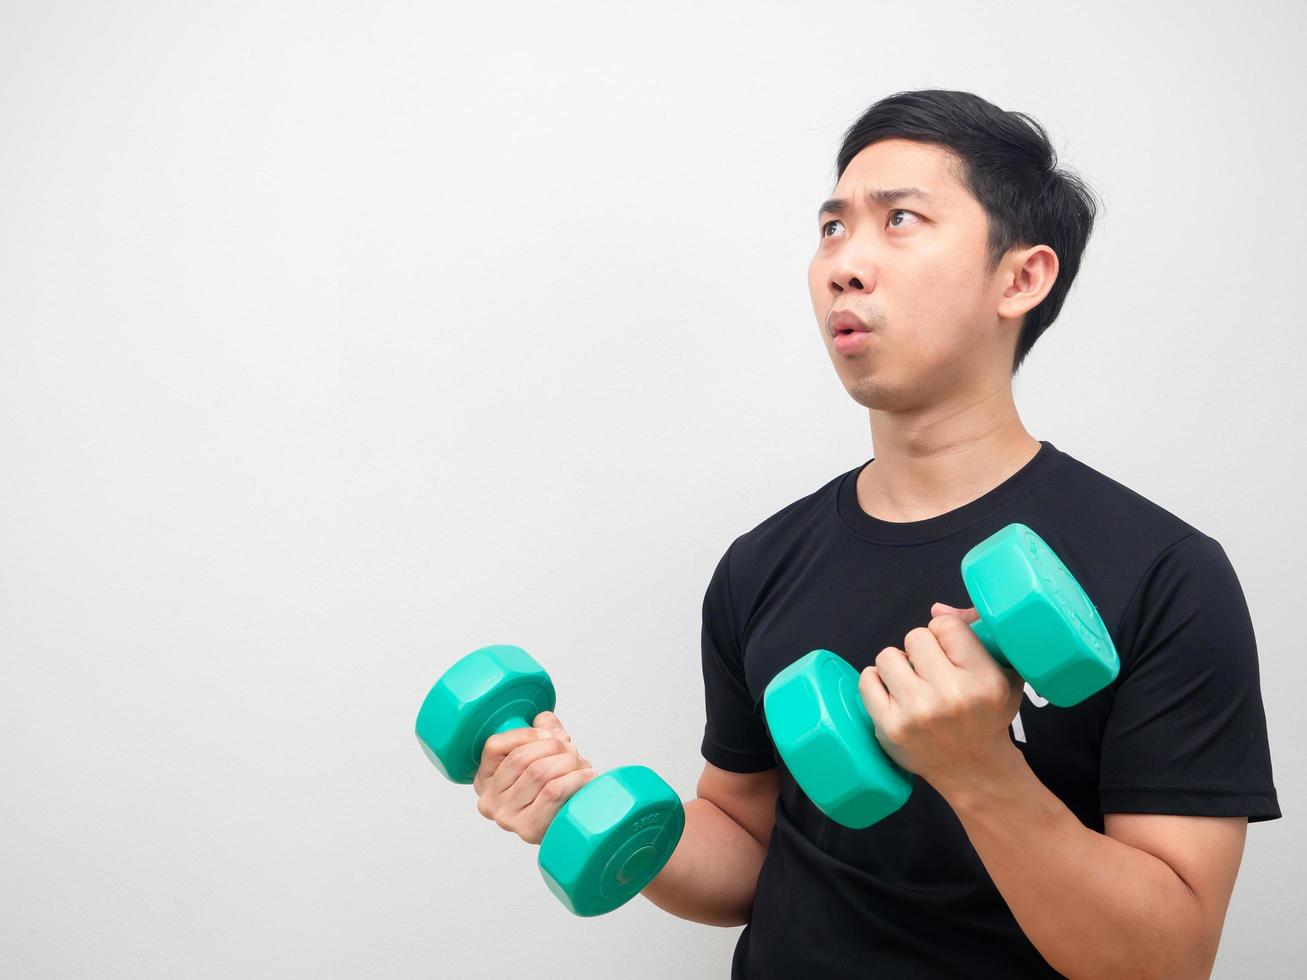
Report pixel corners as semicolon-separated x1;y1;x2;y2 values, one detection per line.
701;544;776;772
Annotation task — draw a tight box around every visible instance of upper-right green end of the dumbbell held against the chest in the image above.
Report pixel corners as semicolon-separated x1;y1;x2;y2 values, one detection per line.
962;523;1120;707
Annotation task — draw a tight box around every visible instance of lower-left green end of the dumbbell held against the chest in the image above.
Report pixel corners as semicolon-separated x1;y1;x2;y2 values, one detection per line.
762;649;912;828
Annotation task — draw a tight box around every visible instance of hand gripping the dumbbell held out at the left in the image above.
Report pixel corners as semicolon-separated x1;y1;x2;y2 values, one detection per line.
472;711;595;844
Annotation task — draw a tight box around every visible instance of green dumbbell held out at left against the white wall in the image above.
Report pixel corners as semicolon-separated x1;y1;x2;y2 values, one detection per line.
417;644;685;916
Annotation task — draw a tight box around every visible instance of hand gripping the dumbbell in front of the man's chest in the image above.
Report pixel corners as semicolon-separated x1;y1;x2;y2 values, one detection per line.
857;602;1025;793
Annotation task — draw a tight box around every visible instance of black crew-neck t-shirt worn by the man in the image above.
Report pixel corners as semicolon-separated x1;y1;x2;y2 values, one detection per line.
702;440;1281;980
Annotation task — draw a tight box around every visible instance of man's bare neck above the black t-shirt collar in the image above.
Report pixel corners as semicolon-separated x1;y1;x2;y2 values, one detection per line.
857;384;1039;521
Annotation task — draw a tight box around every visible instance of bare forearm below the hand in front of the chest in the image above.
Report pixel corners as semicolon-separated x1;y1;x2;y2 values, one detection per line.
938;746;1214;980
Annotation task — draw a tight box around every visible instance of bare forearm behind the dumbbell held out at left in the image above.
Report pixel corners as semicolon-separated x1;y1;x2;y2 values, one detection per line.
640;798;767;925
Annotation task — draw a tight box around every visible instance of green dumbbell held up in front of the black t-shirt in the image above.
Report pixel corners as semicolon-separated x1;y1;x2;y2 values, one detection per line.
763;524;1120;828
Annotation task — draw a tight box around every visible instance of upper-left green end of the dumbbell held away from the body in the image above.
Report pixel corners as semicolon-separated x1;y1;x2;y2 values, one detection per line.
416;643;555;783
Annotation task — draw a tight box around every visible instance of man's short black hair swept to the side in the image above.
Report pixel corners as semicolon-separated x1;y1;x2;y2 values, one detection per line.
835;89;1100;374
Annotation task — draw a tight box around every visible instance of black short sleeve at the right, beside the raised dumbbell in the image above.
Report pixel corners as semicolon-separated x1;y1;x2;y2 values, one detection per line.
1099;531;1281;822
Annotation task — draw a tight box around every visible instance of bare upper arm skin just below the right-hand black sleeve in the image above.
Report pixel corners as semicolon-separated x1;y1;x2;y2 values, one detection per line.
1103;813;1248;970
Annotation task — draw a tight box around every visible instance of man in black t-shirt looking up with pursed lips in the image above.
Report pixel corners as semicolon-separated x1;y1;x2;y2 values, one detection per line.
476;90;1281;980
